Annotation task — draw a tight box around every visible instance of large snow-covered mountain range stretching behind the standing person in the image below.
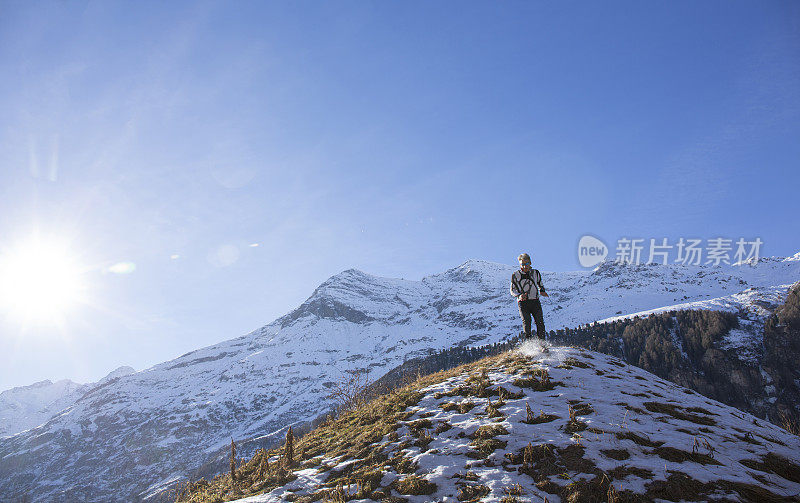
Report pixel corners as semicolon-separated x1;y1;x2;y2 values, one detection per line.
0;254;800;501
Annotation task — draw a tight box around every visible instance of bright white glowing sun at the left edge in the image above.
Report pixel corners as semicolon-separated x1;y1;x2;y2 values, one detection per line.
0;237;83;325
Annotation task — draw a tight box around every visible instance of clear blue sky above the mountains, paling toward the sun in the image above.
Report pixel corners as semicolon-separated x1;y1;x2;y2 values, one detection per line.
0;1;800;389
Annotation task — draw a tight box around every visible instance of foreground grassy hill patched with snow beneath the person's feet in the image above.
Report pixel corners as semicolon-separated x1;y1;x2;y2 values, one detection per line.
228;343;800;503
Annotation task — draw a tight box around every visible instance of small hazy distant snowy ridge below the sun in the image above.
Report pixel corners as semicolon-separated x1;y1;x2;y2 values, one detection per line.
0;366;135;437
